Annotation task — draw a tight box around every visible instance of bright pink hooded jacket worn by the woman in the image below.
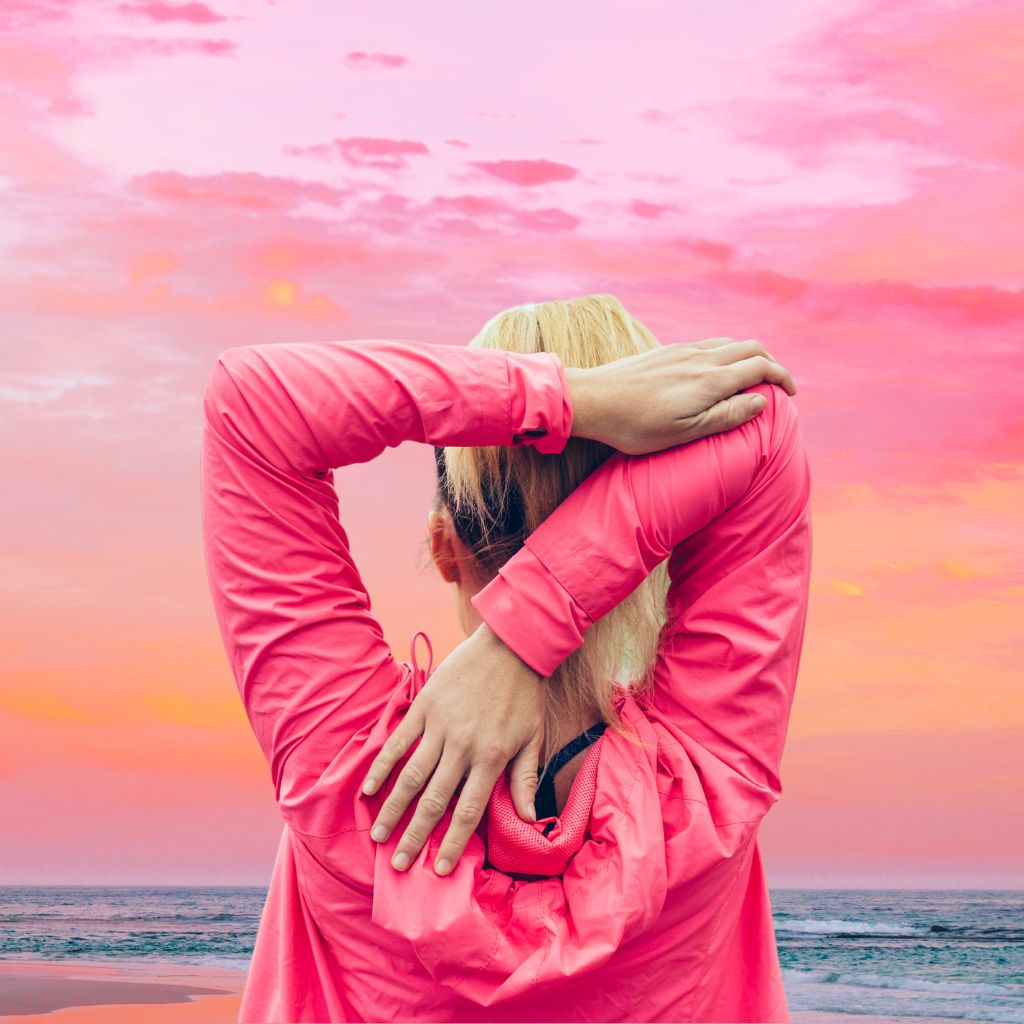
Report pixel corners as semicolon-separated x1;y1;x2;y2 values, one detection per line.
202;331;811;1022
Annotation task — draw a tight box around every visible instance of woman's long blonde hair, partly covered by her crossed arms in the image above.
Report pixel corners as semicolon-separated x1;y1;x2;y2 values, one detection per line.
435;294;669;767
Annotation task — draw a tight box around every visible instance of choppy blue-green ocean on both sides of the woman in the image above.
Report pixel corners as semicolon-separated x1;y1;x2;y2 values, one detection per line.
0;886;1024;1024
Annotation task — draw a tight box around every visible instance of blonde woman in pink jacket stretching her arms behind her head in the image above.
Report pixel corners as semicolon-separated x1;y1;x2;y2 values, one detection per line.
197;295;811;1021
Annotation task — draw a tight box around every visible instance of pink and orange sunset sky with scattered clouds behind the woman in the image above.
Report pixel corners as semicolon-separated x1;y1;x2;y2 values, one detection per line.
0;0;1024;887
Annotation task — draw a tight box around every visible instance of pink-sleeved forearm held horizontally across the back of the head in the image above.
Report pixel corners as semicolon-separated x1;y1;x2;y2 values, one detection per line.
206;340;572;476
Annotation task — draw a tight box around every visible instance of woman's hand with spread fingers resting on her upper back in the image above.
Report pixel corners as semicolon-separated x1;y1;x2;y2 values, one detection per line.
364;623;547;874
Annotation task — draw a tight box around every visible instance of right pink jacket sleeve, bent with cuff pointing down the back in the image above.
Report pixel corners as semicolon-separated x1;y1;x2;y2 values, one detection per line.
472;383;811;813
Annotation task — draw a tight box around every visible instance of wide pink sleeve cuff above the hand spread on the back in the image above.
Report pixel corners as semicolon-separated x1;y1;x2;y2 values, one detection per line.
470;547;593;678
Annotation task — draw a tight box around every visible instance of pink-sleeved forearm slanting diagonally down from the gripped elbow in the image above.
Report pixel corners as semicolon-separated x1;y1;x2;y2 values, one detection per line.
472;385;772;676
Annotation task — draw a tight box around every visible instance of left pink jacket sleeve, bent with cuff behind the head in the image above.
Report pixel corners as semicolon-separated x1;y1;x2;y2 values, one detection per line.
195;340;572;830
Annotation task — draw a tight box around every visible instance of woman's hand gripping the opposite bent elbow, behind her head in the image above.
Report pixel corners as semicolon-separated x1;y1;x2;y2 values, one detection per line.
565;338;797;455
